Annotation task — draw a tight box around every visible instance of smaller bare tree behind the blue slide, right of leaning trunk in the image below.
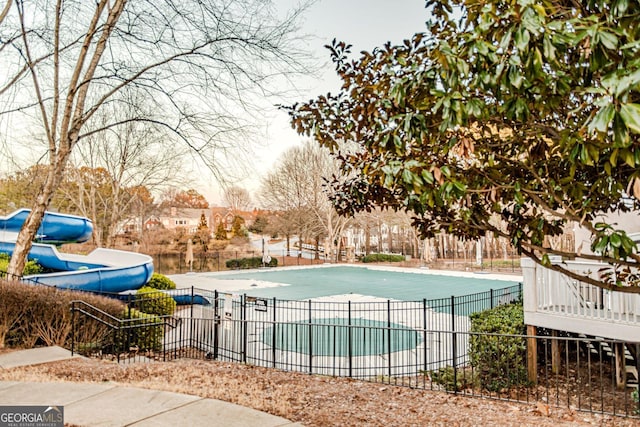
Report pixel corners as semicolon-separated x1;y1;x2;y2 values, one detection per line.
60;95;183;247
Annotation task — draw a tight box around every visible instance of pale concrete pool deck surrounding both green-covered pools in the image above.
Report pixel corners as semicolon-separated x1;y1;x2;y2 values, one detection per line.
169;264;522;378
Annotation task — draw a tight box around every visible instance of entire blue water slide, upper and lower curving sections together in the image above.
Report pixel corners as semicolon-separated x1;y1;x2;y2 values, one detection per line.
0;209;153;293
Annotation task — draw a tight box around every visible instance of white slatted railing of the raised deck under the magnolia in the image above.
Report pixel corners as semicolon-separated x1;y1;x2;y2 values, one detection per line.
522;259;640;340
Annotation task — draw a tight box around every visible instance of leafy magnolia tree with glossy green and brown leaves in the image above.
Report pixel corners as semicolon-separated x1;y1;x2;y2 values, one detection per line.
289;0;640;293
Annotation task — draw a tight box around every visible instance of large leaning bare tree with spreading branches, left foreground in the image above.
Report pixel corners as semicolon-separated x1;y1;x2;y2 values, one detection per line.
0;0;316;275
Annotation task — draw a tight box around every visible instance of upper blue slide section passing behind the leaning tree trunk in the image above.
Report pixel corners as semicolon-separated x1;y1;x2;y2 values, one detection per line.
0;209;93;244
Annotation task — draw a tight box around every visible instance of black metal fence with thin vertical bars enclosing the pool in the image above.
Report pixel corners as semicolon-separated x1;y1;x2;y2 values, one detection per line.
72;286;640;417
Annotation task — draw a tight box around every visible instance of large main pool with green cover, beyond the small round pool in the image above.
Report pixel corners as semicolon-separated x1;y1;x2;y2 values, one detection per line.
210;266;521;301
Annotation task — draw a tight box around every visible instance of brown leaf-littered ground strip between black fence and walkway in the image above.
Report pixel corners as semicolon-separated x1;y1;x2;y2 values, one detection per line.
0;359;640;427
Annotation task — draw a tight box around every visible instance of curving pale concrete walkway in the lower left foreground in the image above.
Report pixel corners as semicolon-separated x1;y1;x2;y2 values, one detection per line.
0;347;301;427
